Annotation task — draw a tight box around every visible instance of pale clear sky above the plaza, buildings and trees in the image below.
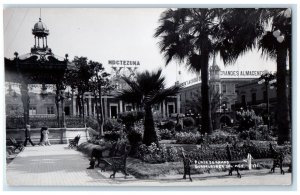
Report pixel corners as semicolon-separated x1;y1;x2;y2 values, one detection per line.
3;8;276;86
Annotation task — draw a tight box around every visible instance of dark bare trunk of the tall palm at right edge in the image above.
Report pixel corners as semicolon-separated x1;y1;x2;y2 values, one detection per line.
277;46;290;145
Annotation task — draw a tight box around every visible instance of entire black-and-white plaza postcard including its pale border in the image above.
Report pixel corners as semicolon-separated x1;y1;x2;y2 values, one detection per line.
1;5;296;189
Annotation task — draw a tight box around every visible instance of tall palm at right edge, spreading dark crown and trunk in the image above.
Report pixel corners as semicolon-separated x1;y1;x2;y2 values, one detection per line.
218;9;291;144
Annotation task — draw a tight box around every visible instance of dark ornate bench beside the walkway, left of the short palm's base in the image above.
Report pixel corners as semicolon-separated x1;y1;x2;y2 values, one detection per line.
98;142;131;178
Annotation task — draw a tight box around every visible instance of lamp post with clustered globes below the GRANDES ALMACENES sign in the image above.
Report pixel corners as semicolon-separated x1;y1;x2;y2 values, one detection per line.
258;73;276;130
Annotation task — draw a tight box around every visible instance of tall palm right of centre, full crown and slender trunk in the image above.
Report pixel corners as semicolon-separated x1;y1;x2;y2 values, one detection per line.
154;8;223;134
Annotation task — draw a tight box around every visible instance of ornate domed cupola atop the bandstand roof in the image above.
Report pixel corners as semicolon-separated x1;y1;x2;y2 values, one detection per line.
31;18;51;53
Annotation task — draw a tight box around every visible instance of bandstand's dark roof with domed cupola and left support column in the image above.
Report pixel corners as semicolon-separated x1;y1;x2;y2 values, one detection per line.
4;18;70;127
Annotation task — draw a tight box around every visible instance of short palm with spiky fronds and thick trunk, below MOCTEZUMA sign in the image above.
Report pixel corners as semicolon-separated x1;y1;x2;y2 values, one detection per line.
117;69;180;145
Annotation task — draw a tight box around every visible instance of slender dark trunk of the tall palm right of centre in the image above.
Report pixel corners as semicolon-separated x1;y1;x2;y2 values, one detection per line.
200;53;212;134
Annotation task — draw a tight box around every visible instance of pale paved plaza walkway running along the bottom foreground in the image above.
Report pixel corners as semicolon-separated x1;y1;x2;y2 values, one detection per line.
6;145;291;187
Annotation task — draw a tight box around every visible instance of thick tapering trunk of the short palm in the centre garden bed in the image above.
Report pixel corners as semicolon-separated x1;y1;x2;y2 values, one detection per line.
143;106;158;146
